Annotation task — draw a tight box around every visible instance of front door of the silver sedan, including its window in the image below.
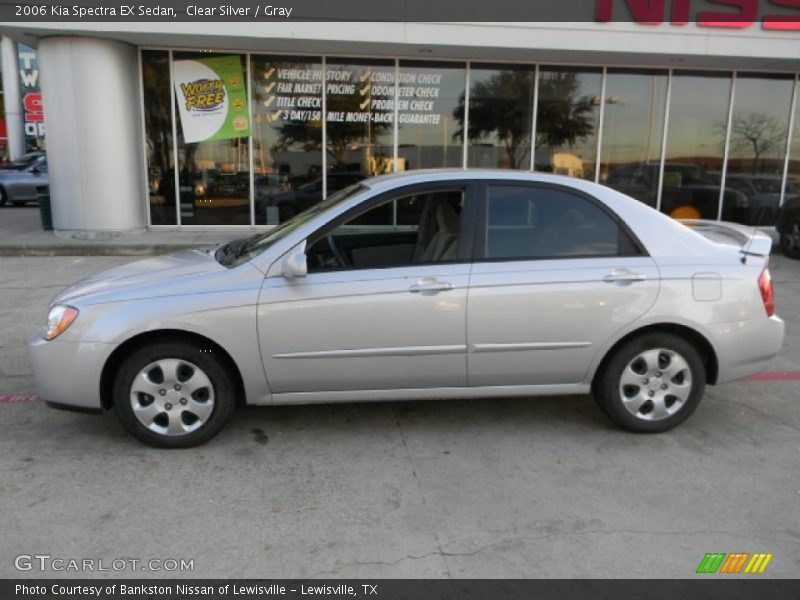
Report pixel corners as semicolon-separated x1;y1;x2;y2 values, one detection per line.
258;182;474;401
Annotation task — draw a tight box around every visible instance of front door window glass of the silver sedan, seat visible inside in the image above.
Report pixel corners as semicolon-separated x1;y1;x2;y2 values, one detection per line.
306;189;464;272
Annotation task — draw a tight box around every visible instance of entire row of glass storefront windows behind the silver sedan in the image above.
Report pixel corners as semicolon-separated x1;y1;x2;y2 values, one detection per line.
142;49;800;226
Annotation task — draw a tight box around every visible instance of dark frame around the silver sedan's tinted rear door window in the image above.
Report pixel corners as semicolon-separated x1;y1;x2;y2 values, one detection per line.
472;179;649;263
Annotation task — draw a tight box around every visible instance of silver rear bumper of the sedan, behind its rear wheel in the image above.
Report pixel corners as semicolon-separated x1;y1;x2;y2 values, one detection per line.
710;316;786;383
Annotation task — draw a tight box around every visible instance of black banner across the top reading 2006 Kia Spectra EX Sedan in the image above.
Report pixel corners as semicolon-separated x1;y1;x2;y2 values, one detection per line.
0;0;800;24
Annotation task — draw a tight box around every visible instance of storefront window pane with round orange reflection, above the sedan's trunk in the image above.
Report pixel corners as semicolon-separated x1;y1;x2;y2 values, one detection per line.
661;71;742;220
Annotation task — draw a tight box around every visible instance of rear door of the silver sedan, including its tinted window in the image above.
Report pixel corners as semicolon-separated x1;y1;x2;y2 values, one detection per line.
467;182;659;386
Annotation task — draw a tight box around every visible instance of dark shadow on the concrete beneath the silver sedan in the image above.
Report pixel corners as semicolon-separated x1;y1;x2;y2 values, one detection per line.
40;395;613;446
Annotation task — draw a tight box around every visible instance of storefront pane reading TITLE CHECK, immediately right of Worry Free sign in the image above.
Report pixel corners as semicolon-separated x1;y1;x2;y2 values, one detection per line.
250;55;322;225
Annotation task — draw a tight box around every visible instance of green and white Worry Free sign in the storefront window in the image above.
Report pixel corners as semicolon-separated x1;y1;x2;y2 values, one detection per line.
174;56;250;144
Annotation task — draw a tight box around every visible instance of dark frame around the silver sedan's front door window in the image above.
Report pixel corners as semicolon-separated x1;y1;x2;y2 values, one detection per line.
306;178;480;276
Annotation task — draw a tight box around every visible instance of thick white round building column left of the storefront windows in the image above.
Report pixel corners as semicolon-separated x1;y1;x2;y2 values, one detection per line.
38;37;147;237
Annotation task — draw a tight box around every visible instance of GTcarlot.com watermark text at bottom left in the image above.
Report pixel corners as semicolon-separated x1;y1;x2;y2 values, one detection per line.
14;554;194;573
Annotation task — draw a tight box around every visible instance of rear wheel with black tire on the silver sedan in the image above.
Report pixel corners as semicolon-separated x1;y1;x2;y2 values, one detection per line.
592;332;706;433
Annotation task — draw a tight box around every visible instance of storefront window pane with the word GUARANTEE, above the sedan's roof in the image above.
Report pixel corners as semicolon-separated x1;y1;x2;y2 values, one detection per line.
397;61;466;171
